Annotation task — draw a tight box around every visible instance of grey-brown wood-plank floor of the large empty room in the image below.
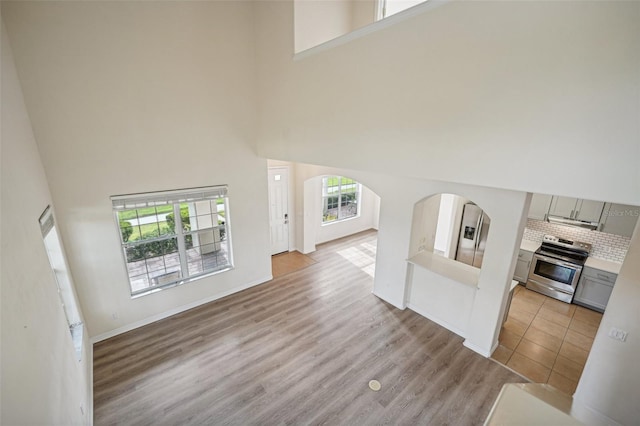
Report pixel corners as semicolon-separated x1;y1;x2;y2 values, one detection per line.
94;231;524;425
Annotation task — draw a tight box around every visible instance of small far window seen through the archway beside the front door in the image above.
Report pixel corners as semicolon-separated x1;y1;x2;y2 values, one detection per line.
322;176;361;223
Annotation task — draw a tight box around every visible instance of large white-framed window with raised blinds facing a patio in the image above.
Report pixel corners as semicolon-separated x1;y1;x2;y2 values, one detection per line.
111;186;233;296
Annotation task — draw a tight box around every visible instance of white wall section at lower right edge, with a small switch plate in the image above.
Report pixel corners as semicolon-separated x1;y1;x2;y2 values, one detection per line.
574;220;640;425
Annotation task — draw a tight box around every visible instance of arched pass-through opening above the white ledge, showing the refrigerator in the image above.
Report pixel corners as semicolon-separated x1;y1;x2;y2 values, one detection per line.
409;194;491;286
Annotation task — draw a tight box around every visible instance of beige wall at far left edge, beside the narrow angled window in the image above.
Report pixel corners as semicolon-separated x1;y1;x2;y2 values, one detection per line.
0;20;93;425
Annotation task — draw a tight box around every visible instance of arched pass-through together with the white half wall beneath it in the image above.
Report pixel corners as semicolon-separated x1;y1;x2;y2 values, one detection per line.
406;194;491;337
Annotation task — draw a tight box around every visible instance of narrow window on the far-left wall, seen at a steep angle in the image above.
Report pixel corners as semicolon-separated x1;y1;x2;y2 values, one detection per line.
39;206;84;361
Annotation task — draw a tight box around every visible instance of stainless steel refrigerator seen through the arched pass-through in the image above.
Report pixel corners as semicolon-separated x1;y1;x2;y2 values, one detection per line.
456;203;491;268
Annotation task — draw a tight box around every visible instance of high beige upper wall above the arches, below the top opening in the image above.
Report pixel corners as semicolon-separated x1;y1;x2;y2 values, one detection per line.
256;1;640;205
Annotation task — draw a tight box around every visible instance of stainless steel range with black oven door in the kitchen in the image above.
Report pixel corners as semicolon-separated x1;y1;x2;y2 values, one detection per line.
527;235;591;303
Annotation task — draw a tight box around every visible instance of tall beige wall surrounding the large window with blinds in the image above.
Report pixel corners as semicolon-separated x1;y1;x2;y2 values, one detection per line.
2;2;271;338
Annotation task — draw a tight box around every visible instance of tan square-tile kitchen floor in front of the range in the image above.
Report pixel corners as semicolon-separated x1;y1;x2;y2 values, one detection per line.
492;285;602;395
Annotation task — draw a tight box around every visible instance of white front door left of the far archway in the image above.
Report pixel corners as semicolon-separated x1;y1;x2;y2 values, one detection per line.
269;167;289;254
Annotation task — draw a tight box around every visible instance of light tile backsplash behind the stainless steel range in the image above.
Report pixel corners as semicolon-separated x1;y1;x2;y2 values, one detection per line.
522;219;631;263
